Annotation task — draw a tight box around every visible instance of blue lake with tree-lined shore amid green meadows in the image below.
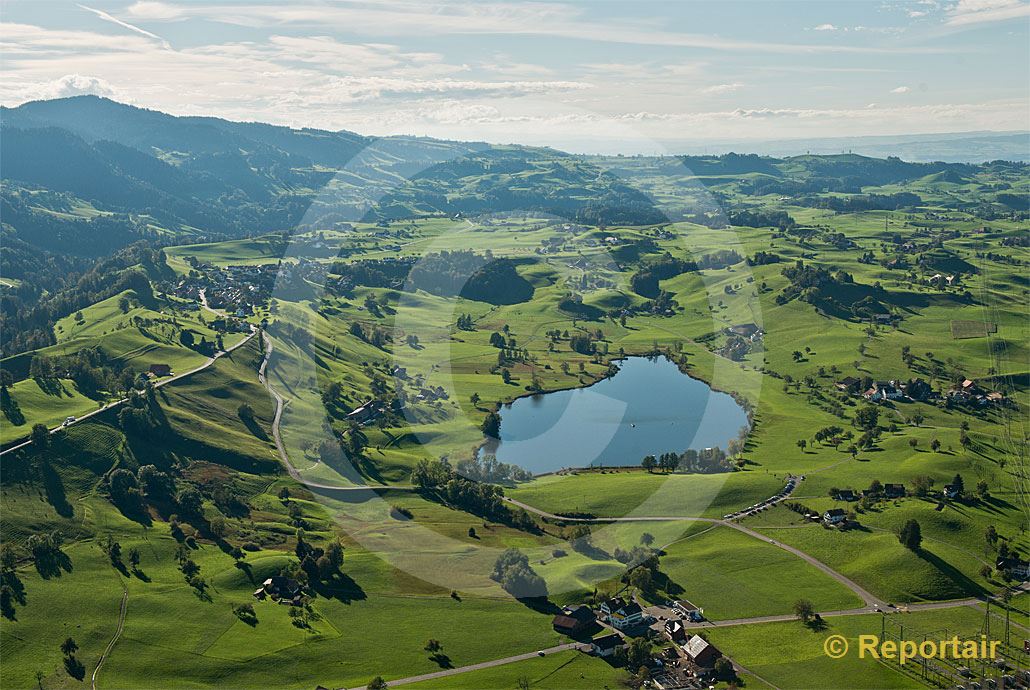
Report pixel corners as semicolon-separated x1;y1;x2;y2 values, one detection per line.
481;357;748;474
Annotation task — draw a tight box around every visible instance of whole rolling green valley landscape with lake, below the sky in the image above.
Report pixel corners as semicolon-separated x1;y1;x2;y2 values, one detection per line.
0;98;1030;688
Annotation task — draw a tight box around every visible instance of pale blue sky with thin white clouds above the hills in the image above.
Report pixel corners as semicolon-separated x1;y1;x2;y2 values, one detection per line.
0;0;1030;153
